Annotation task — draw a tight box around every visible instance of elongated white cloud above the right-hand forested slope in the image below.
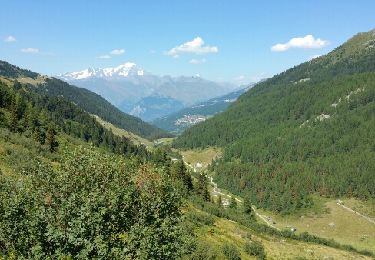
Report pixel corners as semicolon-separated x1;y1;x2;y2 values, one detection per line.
271;34;329;52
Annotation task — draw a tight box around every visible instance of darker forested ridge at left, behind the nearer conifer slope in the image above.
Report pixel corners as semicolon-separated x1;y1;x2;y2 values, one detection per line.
0;61;167;139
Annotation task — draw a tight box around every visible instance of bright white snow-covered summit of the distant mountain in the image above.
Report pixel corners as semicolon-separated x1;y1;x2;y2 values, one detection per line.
59;62;144;81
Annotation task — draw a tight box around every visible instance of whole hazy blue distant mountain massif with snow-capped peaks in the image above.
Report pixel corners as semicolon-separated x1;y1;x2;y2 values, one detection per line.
57;62;242;121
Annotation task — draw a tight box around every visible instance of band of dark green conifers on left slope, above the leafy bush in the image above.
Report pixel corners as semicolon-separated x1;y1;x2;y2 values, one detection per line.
0;81;149;158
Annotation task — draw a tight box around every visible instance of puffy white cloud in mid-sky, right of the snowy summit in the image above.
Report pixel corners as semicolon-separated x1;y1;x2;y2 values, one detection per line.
166;37;219;58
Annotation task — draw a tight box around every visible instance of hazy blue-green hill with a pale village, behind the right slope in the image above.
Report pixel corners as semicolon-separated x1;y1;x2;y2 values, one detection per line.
152;84;253;134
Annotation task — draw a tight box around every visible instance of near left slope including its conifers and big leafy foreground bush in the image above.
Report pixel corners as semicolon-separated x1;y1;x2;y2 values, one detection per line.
0;71;191;259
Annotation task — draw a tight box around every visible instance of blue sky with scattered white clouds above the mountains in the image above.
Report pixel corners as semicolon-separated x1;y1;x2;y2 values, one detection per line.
0;0;375;84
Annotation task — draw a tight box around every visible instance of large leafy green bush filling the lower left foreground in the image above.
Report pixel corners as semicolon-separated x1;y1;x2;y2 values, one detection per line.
0;149;188;259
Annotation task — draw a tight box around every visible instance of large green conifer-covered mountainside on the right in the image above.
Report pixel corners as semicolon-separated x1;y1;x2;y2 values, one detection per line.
174;30;375;213
